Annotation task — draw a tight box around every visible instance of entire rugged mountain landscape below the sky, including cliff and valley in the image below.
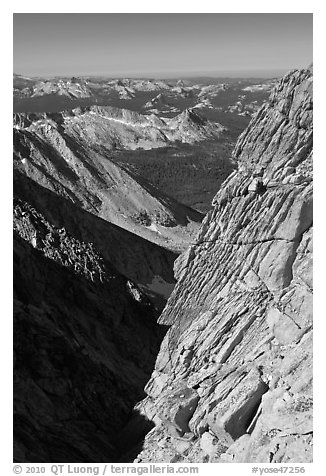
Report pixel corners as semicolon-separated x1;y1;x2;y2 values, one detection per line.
13;67;313;463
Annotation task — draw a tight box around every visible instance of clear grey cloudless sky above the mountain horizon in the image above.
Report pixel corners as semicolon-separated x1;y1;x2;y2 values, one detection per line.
14;13;312;77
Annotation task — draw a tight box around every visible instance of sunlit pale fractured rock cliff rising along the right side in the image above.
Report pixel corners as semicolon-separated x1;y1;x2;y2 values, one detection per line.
136;70;312;463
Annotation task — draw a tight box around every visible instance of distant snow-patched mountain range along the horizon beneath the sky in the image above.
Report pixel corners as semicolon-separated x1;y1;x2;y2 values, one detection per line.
13;74;275;122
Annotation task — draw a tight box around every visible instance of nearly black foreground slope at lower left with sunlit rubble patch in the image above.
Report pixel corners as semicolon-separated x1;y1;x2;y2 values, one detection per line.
14;192;169;463
